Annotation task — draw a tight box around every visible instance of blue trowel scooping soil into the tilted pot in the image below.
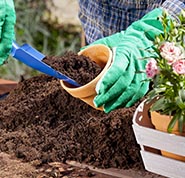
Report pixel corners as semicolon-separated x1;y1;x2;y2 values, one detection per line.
11;42;80;87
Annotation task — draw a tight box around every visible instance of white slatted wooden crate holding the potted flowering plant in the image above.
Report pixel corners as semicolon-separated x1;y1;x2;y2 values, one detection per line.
133;101;185;178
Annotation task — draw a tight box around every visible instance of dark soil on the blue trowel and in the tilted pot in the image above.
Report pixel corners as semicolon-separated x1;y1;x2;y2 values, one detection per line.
42;52;102;85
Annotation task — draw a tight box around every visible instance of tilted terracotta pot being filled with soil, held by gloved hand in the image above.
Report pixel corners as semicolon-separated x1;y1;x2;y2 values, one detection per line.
60;44;112;110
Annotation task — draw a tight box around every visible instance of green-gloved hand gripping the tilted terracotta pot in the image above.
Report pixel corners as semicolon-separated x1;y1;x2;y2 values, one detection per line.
85;8;163;113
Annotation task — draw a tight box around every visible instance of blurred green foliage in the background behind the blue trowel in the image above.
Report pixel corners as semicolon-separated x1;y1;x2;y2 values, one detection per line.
0;0;81;81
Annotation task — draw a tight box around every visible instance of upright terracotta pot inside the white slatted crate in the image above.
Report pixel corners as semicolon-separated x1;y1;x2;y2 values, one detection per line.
151;111;185;161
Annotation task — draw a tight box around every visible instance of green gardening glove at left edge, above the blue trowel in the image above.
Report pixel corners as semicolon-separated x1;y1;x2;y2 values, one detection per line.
0;0;16;65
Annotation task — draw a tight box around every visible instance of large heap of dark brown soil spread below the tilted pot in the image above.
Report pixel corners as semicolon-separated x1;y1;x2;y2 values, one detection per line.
0;52;143;170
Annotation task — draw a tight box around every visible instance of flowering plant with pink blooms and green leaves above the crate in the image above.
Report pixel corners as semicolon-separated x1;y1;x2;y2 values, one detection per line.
146;9;185;134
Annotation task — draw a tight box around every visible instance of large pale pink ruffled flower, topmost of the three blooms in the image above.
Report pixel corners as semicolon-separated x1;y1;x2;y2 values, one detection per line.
159;42;182;65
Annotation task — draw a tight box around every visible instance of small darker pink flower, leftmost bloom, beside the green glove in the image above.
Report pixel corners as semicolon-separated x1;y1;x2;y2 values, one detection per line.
146;58;159;78
